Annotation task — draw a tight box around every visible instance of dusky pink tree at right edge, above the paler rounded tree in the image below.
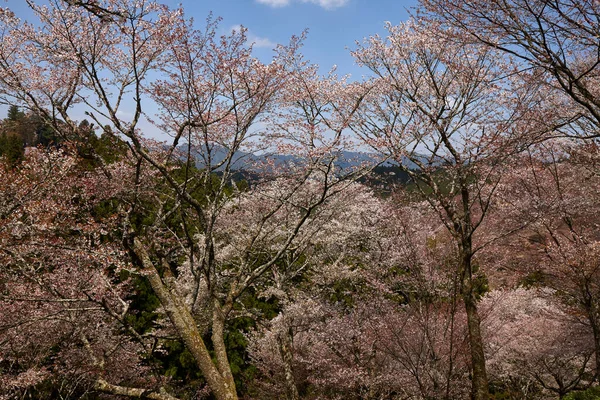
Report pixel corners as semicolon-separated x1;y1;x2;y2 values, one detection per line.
486;142;600;379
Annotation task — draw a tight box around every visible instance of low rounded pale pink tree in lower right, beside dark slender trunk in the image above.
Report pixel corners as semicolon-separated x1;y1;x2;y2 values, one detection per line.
482;288;594;398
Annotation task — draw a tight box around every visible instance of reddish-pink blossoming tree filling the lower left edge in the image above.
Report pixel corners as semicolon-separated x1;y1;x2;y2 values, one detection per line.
0;149;169;399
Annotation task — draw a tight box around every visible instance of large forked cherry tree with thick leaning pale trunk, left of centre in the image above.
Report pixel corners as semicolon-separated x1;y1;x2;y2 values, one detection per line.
0;0;372;399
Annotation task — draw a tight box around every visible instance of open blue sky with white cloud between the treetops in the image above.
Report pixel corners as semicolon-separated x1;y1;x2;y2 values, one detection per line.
172;0;417;78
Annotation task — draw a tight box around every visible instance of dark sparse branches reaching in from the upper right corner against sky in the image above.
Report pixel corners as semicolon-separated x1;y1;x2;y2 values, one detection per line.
421;0;600;138
